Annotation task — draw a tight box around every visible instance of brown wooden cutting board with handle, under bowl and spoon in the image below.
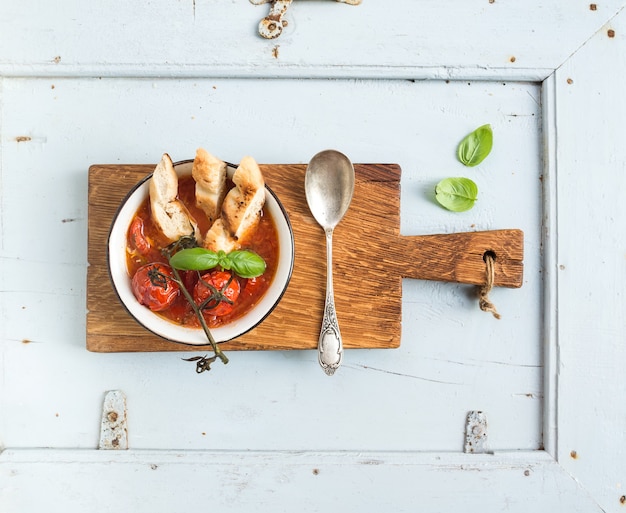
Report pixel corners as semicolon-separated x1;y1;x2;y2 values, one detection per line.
87;164;523;352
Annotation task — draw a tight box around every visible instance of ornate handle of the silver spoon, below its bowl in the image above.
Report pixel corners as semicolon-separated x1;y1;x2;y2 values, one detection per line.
317;228;343;376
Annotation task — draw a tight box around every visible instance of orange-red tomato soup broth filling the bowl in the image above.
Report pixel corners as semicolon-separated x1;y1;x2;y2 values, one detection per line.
126;176;279;328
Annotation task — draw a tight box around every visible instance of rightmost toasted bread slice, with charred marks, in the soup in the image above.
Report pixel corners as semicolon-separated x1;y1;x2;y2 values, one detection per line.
204;157;265;252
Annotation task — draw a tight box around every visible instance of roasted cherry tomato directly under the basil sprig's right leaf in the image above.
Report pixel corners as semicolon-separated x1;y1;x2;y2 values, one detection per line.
193;271;241;317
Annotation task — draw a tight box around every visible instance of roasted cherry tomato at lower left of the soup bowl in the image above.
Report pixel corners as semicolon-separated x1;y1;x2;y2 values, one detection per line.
132;263;180;312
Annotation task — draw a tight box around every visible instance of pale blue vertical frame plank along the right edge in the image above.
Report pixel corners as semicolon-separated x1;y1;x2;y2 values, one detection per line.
550;6;626;512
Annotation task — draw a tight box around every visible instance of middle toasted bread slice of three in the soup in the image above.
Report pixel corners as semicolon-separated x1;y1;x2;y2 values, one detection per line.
191;148;226;223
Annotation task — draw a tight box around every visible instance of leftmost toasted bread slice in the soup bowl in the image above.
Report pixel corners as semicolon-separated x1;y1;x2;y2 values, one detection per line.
150;153;197;242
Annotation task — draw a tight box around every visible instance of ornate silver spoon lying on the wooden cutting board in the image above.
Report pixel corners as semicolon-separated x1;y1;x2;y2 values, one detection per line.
304;150;354;376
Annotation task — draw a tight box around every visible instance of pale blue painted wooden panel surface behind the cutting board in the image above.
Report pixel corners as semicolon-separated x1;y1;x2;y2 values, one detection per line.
0;0;626;512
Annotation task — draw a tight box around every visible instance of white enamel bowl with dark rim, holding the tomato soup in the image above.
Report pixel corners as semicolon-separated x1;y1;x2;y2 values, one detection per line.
107;160;294;345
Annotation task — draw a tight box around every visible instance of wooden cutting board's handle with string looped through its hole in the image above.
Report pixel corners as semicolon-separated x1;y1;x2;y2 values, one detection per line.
394;229;524;288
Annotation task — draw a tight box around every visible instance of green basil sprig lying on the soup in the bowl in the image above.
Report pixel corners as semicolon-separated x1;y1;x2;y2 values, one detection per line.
170;248;266;278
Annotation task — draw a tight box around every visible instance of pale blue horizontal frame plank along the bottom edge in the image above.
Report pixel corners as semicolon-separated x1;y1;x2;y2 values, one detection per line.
0;449;604;513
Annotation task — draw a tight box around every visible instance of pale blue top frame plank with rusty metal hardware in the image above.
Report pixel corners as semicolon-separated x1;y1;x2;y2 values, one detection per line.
0;0;624;80
